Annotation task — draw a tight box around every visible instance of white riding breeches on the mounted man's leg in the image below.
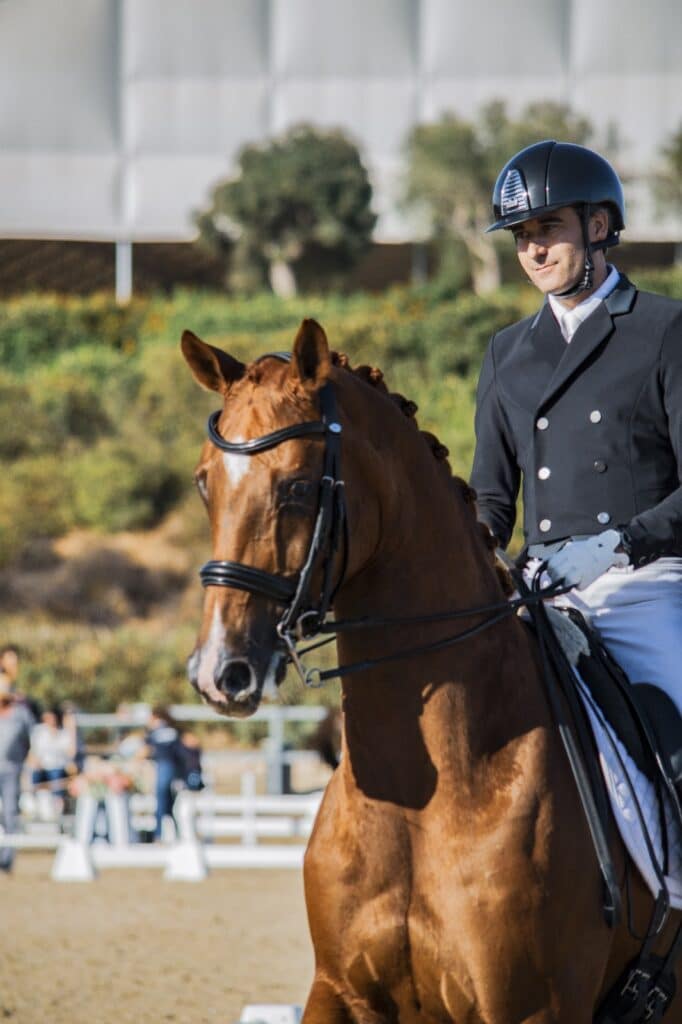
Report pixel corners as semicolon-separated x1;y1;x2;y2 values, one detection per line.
528;557;682;713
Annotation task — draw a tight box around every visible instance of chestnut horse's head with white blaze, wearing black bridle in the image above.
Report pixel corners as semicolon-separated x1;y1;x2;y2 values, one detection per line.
182;321;379;716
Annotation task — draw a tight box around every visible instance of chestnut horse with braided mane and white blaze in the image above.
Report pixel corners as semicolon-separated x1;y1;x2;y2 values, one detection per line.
182;321;682;1024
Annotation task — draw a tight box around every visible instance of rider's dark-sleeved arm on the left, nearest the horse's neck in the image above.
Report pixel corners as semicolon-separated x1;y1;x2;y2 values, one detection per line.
471;337;521;548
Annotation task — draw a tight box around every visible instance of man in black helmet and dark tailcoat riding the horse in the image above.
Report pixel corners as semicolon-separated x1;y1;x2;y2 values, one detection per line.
471;140;682;791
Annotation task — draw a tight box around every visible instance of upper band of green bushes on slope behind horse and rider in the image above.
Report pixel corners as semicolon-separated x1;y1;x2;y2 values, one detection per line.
0;269;682;564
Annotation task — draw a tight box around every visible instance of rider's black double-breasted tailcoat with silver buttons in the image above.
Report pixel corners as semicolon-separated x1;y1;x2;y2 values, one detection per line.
471;275;682;564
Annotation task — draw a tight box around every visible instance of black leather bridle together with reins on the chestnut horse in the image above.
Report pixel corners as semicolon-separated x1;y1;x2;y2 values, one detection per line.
200;352;565;687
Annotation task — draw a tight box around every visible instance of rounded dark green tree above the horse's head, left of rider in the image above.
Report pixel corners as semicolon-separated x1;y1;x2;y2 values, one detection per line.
197;126;376;296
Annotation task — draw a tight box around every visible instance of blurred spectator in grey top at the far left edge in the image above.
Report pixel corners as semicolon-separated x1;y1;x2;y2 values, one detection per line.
0;674;34;873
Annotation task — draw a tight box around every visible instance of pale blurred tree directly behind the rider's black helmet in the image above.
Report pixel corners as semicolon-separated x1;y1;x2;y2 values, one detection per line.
406;100;592;295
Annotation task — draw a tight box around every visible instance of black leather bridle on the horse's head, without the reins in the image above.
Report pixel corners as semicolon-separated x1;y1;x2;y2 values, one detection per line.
200;352;348;678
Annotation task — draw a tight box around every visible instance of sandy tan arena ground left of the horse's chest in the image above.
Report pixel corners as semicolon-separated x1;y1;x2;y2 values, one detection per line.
0;852;312;1024
